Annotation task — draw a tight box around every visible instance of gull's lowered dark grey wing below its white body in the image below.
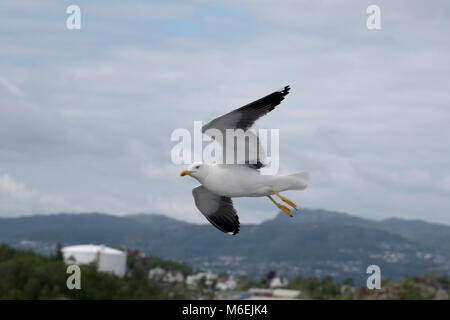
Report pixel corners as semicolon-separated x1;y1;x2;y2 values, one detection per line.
192;186;239;235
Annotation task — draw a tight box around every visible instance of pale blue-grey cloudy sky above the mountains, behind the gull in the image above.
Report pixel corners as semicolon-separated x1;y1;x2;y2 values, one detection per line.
0;0;450;224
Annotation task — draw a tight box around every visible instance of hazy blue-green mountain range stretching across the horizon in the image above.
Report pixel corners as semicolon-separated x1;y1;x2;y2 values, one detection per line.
0;209;450;283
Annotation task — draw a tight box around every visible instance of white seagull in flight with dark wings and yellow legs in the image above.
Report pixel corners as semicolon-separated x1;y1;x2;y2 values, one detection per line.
180;86;309;235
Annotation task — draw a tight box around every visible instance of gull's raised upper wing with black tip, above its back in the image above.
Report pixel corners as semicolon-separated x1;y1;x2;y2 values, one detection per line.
202;86;291;169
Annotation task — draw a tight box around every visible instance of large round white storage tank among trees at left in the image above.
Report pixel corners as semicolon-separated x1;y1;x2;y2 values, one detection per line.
61;244;127;277
